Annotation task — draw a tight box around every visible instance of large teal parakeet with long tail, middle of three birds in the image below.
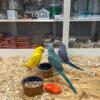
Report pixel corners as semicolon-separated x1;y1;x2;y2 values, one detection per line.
47;43;77;93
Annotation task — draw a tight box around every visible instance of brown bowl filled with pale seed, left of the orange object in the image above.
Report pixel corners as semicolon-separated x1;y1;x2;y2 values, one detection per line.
22;76;43;97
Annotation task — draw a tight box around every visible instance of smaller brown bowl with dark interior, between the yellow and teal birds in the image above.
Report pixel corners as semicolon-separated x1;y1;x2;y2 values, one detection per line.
38;63;53;78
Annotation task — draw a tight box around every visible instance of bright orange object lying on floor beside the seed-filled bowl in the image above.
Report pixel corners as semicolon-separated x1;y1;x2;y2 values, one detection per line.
44;83;62;94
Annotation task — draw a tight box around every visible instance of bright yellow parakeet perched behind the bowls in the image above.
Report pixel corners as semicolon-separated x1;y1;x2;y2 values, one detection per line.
24;47;44;68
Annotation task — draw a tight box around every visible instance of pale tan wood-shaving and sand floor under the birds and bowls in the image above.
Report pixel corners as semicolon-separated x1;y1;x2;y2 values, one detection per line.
0;55;100;100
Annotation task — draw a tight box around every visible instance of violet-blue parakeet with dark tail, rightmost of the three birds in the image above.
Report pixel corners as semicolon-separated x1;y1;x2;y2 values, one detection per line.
58;44;83;70
